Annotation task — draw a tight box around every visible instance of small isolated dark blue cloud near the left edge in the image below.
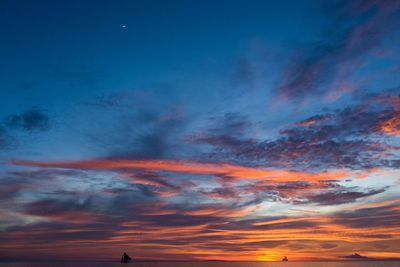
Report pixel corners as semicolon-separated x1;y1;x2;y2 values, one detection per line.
4;108;50;132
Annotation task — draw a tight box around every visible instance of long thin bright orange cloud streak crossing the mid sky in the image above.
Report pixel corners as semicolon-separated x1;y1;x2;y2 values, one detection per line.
12;159;351;182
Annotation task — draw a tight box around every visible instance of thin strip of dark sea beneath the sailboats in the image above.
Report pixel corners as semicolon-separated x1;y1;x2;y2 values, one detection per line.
0;261;400;267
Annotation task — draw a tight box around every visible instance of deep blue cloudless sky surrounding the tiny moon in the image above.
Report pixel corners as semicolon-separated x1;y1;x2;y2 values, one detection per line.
1;1;324;112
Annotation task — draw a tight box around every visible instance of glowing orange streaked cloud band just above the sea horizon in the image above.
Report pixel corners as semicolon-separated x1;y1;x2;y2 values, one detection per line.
0;208;400;261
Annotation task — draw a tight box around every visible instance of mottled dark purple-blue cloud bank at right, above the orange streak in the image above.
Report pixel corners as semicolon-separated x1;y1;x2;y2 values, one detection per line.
255;104;396;169
